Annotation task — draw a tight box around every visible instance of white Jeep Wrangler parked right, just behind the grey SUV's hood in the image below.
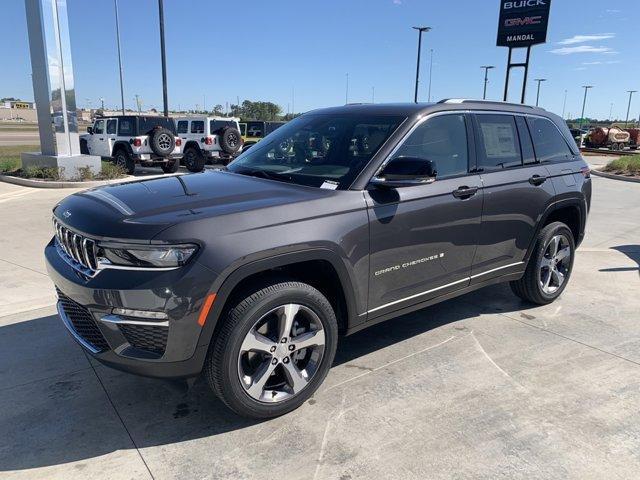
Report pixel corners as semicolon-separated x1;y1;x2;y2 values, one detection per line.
175;116;242;172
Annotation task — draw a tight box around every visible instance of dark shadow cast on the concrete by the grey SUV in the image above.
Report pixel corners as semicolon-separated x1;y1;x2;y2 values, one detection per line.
0;285;527;471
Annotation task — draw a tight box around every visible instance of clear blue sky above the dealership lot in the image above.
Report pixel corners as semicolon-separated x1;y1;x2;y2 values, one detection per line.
0;0;640;118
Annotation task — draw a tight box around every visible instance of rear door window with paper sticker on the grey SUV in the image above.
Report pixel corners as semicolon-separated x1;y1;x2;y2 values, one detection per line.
476;114;522;172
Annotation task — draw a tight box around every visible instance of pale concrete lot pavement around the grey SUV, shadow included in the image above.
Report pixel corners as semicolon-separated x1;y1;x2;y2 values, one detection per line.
0;162;640;480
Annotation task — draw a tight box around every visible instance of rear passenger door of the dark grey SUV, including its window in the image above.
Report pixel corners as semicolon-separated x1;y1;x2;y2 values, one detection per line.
471;113;555;283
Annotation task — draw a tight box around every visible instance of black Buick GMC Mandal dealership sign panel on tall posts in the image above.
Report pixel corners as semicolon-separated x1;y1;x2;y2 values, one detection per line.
496;0;551;48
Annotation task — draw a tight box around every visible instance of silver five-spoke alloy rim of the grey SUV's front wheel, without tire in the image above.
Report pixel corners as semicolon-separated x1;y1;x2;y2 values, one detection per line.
238;303;325;403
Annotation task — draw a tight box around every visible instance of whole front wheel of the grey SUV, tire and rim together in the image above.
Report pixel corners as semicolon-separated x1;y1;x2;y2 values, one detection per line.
204;280;338;419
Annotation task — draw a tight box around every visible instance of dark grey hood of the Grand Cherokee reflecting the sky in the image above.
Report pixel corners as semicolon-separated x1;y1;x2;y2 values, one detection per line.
54;171;333;241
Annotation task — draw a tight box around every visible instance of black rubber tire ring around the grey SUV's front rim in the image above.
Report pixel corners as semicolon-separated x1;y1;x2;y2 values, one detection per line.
214;282;338;418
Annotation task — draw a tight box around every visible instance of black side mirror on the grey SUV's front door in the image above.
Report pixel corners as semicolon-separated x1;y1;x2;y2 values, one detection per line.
370;157;438;188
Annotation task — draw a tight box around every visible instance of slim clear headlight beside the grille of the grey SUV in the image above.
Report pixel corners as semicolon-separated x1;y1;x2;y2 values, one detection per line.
97;244;198;269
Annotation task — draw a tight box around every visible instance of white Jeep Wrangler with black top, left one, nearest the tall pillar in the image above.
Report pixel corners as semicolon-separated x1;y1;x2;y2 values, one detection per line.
80;115;182;175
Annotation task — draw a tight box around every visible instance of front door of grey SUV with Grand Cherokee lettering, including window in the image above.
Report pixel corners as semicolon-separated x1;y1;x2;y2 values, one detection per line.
365;113;482;318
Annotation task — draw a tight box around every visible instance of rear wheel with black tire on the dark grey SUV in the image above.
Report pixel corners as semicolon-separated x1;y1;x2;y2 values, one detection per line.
510;222;576;305
